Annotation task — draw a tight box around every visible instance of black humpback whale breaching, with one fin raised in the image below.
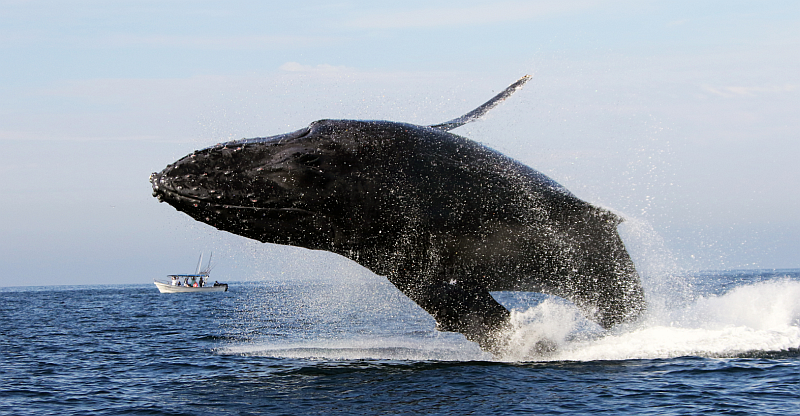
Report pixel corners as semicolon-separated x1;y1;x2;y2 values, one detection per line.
150;76;645;351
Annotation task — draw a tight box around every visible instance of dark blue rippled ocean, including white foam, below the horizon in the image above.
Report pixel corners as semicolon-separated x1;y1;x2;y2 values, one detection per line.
0;270;800;415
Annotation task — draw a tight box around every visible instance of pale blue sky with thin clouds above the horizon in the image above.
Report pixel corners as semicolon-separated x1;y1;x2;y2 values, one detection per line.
0;0;800;286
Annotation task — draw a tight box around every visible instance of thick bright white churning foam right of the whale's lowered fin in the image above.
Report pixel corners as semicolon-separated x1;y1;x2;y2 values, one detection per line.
502;280;800;361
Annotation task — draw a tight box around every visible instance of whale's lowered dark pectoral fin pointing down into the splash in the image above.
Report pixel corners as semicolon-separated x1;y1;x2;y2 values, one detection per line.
406;282;510;351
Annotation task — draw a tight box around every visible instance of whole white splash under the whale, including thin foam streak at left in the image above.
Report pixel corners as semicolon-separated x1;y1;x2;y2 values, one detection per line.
219;279;800;362
